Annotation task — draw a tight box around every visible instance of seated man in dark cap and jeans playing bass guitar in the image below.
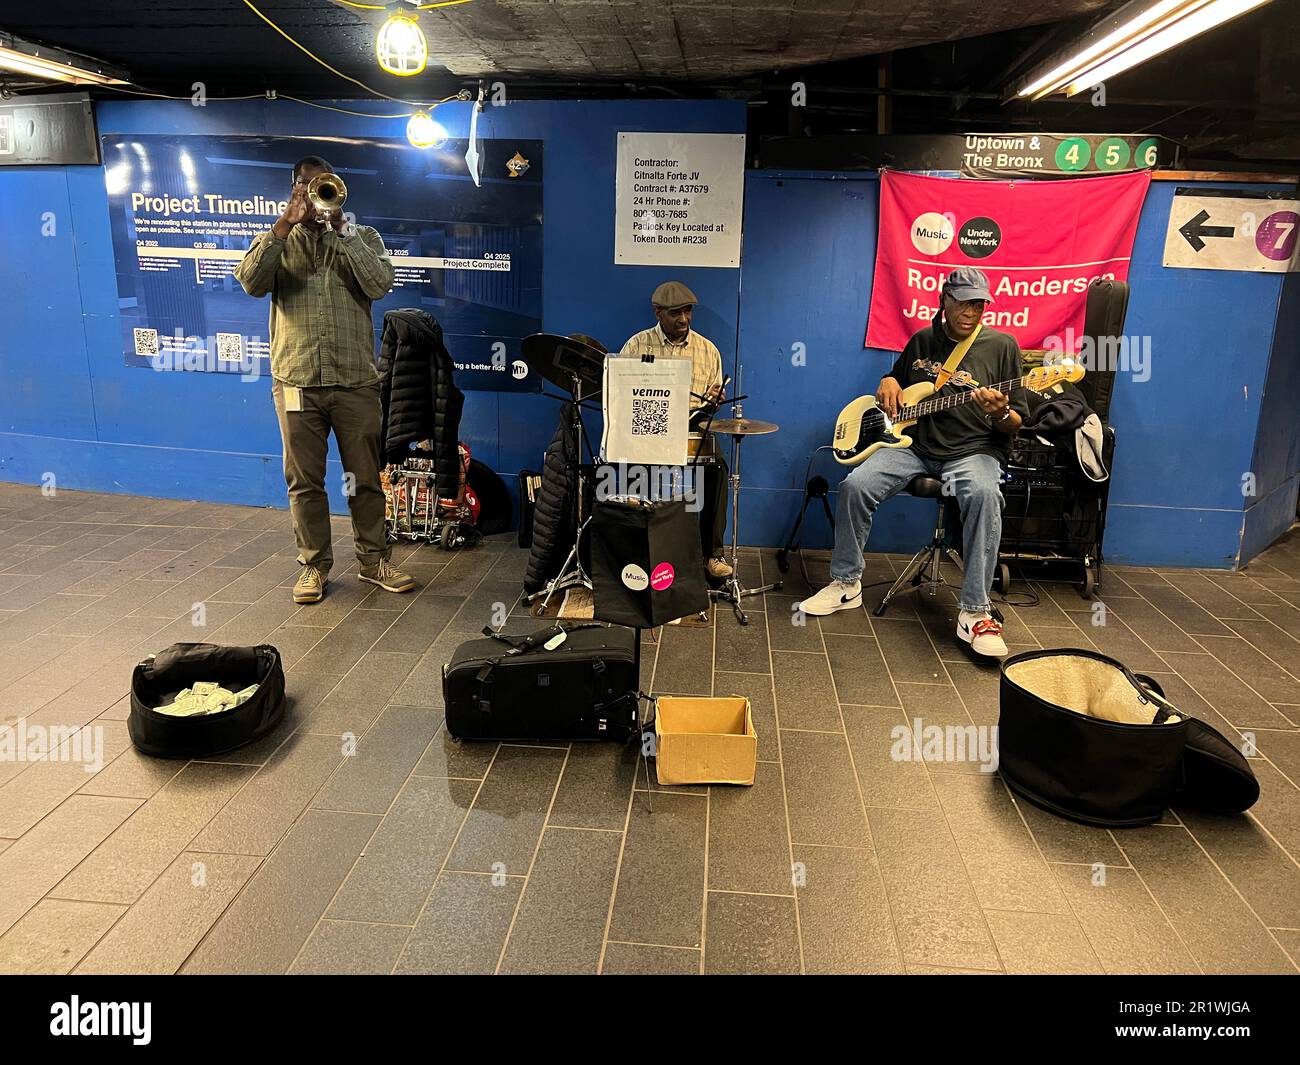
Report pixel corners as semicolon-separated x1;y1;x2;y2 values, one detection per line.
800;267;1027;658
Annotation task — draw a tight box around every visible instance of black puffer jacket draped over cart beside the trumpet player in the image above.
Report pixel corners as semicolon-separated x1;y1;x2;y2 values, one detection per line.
377;308;465;497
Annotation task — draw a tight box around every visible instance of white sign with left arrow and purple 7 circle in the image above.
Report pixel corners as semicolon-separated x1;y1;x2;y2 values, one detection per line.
1165;189;1300;273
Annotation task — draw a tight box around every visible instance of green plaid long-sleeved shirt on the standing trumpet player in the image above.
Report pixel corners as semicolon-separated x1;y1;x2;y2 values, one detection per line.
235;225;393;389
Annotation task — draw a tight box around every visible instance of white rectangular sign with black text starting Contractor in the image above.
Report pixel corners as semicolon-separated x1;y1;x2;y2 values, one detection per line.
614;133;745;267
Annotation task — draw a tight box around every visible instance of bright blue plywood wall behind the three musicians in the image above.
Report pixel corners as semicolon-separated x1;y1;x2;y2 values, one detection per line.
0;95;1300;566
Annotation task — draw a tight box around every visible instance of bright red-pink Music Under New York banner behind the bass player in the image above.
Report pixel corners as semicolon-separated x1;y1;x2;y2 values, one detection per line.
866;170;1151;351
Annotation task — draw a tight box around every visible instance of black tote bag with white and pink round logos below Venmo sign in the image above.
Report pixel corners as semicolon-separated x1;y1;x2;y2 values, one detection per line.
592;499;709;628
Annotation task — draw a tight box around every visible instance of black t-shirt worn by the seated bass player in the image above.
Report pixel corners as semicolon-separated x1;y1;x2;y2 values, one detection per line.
885;321;1028;463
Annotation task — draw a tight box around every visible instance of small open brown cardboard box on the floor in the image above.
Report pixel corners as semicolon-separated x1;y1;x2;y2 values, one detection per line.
654;696;758;784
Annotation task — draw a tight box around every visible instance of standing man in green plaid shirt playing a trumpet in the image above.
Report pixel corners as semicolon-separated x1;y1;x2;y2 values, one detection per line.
235;155;415;603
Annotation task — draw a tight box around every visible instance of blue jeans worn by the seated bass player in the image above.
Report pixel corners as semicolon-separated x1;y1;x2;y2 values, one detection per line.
831;447;1002;612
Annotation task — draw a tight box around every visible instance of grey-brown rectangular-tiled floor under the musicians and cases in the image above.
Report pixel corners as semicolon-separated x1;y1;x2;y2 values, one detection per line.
0;485;1300;973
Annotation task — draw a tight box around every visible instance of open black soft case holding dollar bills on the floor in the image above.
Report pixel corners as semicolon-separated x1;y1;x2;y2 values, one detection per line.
127;644;285;758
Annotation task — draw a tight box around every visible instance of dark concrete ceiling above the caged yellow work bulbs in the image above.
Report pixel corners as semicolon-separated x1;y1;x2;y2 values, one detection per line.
0;0;1118;92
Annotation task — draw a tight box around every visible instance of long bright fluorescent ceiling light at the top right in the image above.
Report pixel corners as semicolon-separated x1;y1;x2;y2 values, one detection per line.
1015;0;1269;100
